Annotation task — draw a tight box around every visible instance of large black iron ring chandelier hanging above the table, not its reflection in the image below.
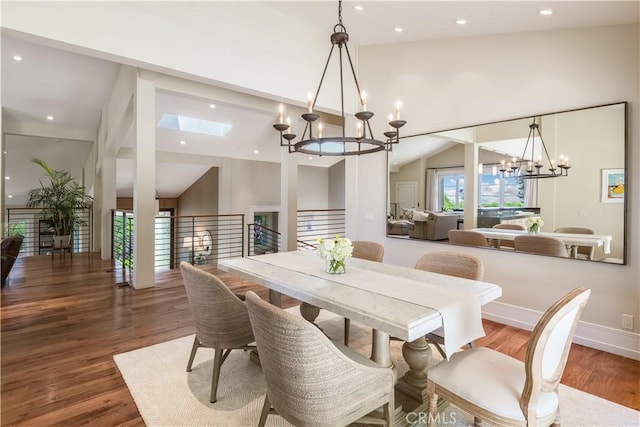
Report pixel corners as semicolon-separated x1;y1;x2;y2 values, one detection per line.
273;1;406;156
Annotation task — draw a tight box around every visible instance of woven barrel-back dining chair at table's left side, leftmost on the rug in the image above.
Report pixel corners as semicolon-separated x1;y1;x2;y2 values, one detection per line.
180;261;256;403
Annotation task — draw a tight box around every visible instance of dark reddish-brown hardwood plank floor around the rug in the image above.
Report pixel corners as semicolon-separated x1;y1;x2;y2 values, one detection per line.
0;254;640;426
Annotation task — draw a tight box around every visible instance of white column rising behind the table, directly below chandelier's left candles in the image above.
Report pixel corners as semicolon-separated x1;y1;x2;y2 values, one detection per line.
278;148;298;252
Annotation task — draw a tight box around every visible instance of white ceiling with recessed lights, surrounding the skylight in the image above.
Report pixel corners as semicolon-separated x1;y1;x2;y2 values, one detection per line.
1;1;639;205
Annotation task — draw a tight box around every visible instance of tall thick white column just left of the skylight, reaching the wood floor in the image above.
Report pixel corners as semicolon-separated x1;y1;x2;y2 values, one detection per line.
132;78;156;289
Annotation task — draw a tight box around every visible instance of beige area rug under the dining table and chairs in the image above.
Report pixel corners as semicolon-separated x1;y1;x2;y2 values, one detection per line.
114;309;640;427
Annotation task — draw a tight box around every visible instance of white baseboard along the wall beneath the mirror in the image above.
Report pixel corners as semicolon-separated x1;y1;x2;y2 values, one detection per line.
482;301;640;360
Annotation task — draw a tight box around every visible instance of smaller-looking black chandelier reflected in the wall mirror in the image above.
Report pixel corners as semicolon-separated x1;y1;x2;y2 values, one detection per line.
499;117;571;179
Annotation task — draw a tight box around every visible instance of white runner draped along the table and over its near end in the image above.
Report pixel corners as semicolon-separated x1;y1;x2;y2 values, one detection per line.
251;252;485;358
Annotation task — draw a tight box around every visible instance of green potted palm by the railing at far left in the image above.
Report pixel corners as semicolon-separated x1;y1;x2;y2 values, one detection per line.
27;159;93;248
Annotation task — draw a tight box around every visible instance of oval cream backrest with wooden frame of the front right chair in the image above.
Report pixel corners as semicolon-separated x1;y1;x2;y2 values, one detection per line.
520;288;591;420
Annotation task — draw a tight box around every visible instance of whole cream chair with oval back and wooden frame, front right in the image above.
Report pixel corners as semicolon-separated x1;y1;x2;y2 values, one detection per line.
423;288;591;426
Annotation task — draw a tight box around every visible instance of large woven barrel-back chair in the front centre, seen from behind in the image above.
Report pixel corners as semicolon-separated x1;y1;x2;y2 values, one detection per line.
246;291;395;427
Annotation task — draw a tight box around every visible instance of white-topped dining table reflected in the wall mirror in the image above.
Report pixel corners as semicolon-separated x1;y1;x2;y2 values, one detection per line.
470;228;613;258
